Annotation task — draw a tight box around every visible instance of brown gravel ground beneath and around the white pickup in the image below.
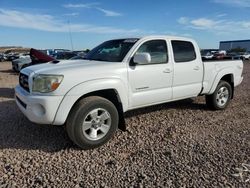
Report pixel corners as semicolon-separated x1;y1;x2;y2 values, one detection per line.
0;62;250;187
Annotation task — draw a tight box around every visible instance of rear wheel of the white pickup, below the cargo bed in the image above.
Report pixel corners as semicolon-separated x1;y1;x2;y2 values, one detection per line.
206;80;232;110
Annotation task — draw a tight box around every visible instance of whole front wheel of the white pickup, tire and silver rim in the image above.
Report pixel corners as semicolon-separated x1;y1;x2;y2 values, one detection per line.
66;96;119;149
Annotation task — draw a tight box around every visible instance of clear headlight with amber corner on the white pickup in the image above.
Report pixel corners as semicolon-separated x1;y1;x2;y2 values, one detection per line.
32;74;63;93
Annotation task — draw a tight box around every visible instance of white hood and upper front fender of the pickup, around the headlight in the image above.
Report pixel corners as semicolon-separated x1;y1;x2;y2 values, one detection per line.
21;60;127;95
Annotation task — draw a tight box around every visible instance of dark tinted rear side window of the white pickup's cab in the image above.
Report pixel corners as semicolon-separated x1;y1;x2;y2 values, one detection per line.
171;40;196;63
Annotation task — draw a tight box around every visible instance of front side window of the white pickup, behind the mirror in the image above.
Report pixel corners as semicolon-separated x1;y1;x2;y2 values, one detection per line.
136;40;168;64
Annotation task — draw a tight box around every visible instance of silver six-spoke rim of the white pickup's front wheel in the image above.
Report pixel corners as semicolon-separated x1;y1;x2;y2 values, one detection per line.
82;108;111;140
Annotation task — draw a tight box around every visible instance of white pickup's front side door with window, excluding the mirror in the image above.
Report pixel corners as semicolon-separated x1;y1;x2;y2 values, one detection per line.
128;39;173;108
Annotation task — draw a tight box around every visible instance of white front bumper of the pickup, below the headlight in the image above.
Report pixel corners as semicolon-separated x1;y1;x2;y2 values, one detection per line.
15;85;63;124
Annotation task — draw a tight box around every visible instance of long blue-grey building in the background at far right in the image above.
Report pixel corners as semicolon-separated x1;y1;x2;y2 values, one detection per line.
220;39;250;51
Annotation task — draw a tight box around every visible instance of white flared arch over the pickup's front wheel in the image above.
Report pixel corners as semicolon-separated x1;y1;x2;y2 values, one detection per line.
53;79;128;129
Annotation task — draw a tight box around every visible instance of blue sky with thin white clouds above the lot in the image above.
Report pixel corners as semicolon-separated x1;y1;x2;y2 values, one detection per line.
0;0;250;50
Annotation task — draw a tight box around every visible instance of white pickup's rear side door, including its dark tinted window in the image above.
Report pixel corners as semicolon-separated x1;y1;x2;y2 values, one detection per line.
171;40;203;99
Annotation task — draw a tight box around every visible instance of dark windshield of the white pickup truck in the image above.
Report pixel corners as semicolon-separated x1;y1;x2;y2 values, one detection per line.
84;38;139;62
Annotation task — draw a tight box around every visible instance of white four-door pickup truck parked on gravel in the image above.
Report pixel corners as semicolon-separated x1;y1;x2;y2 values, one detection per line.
15;36;243;149
